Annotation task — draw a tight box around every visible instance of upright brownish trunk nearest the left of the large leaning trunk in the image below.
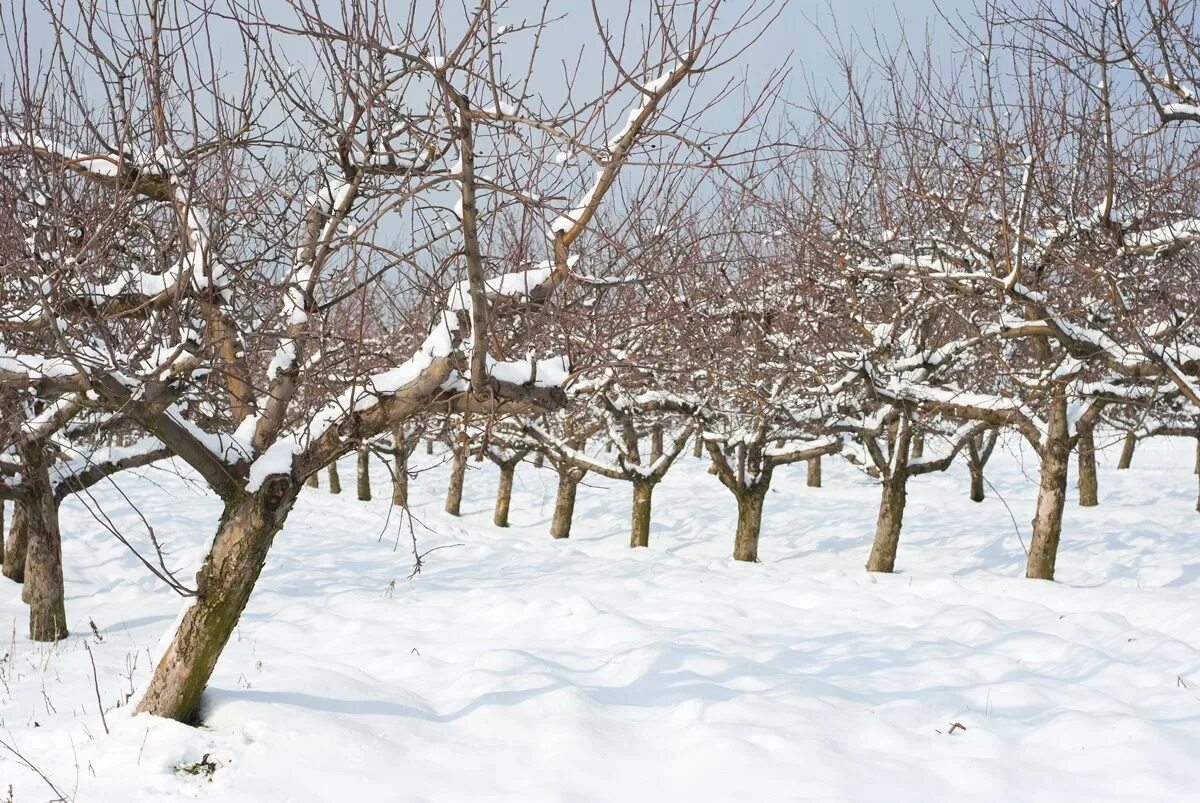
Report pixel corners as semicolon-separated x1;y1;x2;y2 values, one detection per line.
20;445;67;641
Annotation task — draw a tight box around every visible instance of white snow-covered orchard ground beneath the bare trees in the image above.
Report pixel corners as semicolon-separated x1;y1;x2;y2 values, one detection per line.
0;441;1200;803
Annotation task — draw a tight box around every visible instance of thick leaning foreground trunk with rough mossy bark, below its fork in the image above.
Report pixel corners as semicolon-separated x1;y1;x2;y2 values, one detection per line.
137;477;299;723
